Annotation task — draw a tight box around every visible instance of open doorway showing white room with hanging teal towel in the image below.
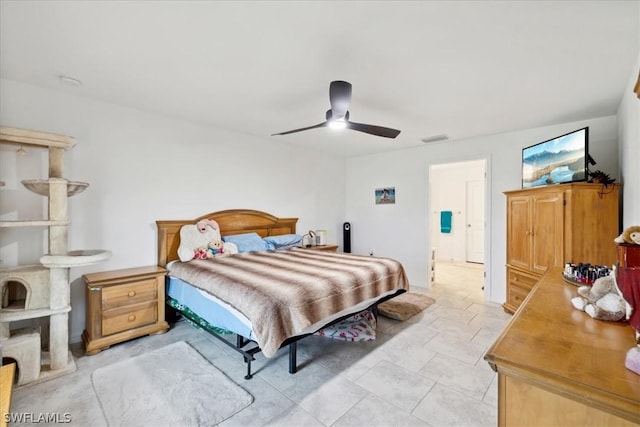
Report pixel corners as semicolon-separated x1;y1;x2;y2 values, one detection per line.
428;159;488;292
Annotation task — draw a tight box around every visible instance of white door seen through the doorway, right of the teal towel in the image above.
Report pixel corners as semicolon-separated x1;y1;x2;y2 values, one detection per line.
467;180;484;264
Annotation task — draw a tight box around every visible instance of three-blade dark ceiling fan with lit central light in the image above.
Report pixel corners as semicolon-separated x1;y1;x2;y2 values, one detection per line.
271;80;400;138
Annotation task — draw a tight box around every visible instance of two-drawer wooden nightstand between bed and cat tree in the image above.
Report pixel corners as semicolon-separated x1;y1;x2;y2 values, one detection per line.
82;266;169;355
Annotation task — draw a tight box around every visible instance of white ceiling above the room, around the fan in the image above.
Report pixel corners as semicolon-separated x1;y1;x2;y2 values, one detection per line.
0;0;640;156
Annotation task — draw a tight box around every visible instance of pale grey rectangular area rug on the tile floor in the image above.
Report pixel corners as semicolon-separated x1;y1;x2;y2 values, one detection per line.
91;341;253;426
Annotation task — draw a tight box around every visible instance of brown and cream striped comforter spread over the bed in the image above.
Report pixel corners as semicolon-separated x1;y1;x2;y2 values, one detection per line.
169;248;409;357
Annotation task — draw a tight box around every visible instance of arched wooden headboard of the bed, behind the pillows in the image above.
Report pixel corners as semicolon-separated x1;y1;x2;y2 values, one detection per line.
156;209;298;267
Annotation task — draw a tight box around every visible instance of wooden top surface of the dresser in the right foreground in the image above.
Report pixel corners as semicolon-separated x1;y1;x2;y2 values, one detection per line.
485;268;640;423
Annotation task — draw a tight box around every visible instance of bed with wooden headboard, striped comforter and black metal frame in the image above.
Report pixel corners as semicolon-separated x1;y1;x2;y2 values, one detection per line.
156;209;409;379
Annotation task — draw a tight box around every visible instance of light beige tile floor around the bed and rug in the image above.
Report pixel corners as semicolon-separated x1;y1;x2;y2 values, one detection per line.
11;261;510;427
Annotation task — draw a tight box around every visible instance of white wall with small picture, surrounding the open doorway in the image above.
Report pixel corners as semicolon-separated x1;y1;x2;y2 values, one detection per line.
345;116;619;303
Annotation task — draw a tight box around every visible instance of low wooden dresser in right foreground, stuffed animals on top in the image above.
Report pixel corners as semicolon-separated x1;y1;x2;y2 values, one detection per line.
485;267;640;427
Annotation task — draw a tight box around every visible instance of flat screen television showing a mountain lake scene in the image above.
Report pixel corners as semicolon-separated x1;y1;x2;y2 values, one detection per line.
522;127;589;188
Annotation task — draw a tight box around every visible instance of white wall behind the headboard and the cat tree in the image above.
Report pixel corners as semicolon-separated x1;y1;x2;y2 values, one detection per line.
0;80;345;342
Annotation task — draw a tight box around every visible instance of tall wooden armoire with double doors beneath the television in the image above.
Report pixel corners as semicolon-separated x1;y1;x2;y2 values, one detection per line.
503;183;620;313
